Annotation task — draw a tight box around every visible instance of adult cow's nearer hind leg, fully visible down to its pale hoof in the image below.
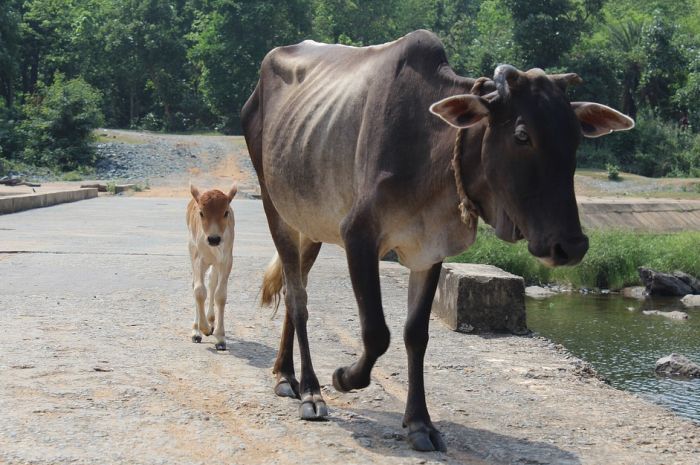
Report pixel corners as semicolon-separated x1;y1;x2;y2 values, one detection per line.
261;198;328;420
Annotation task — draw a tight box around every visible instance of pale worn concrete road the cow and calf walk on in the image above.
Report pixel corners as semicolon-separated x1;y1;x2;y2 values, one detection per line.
0;197;700;465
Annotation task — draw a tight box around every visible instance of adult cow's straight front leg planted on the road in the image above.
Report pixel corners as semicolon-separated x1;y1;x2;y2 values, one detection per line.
403;263;445;452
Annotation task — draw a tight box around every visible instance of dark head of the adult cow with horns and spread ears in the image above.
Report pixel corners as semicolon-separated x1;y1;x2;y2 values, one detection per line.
430;65;634;266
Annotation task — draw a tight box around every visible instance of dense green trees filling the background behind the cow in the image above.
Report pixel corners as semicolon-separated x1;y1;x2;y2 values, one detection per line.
0;0;700;176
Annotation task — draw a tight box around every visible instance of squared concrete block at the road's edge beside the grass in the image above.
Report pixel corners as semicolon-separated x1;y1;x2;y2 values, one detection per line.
433;263;529;334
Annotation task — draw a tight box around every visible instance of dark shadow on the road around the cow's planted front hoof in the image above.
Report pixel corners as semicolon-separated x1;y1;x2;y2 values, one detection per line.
331;409;581;465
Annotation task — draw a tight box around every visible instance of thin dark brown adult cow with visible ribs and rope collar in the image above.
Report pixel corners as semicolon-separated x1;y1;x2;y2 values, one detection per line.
241;31;634;450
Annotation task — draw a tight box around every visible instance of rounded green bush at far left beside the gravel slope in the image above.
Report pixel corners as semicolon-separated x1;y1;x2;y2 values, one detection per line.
20;75;103;171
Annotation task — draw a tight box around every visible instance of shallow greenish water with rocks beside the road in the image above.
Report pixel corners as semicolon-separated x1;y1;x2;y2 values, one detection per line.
526;294;700;423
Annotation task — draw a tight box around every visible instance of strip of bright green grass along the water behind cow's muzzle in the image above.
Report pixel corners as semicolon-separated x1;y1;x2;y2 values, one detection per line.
449;225;700;289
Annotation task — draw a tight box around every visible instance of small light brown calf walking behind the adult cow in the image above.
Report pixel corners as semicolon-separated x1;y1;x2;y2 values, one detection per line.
187;184;237;350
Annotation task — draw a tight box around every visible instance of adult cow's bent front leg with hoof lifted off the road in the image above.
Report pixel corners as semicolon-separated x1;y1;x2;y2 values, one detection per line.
333;225;390;392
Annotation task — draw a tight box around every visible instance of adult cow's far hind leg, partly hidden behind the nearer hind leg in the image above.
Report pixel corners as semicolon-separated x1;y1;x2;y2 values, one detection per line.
272;238;321;398
